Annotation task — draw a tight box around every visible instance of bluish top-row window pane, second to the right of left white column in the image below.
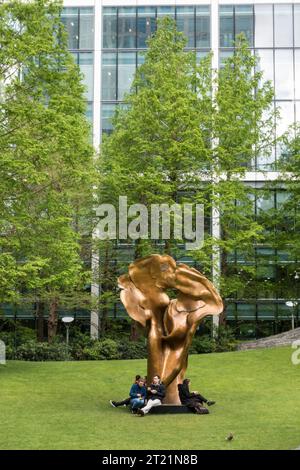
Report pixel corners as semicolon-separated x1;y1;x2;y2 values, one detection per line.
118;7;136;49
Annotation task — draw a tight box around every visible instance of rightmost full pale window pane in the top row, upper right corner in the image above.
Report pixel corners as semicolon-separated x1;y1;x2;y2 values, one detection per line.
274;4;293;47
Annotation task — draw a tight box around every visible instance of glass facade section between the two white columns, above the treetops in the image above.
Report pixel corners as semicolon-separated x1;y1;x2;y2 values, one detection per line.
101;5;211;133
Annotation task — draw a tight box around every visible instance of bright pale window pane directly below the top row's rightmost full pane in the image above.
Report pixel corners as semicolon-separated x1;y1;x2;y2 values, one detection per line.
275;49;294;99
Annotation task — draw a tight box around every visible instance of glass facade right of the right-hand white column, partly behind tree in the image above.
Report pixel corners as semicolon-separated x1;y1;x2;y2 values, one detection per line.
219;3;300;171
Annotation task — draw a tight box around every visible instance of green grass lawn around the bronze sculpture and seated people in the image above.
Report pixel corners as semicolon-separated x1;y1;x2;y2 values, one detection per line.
0;348;300;450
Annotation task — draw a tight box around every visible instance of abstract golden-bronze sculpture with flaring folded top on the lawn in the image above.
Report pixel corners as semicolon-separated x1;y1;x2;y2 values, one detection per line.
118;255;223;404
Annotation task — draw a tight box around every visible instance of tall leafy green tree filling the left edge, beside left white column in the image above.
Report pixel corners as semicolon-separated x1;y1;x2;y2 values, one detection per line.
0;0;95;341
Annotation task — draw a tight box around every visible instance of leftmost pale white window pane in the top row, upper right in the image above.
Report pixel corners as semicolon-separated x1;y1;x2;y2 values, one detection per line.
254;5;273;47
